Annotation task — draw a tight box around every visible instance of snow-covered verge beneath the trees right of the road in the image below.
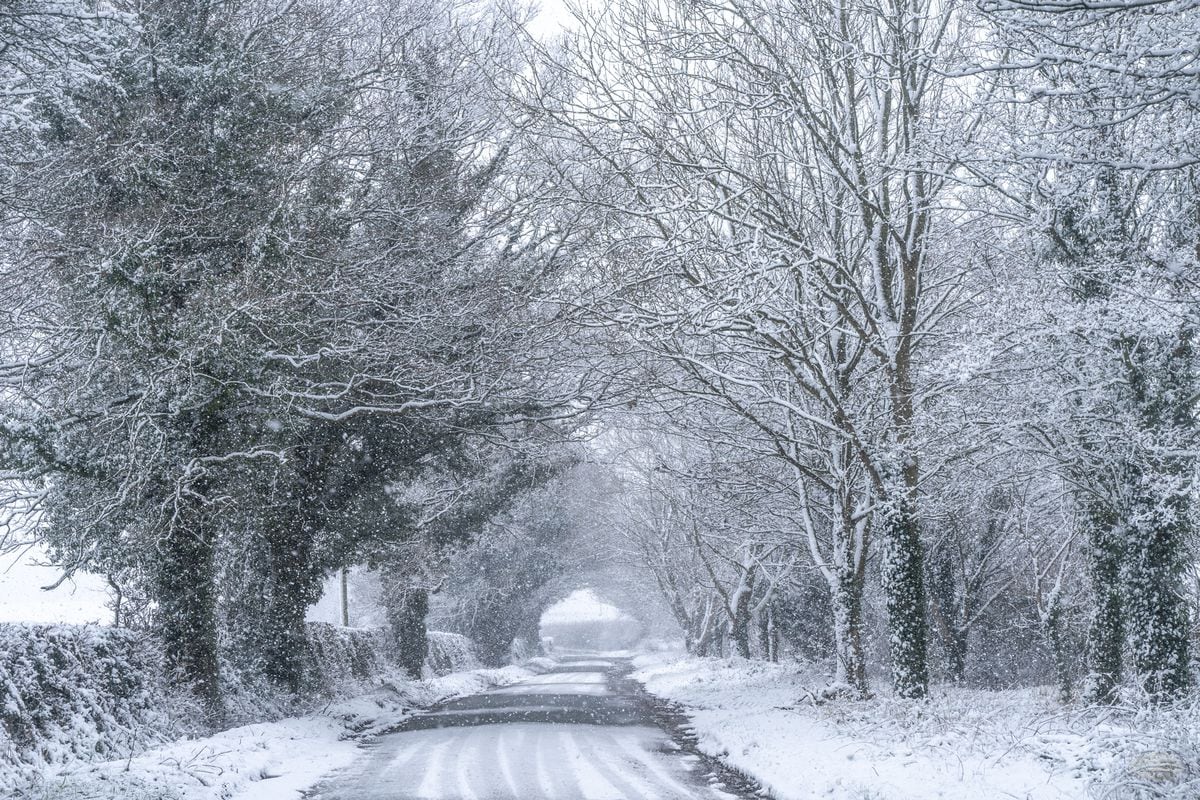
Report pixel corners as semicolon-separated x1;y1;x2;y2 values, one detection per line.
635;655;1200;800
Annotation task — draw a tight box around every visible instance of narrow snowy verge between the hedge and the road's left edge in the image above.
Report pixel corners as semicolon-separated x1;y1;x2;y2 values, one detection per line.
19;667;530;800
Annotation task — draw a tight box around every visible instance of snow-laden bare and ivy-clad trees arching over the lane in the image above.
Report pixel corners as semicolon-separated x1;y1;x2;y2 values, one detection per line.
0;0;1200;722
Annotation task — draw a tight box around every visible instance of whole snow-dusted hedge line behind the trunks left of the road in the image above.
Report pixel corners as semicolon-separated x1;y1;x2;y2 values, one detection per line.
0;622;479;794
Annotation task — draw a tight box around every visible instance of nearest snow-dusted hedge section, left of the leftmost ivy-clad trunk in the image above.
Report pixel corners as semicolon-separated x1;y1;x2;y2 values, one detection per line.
0;624;182;784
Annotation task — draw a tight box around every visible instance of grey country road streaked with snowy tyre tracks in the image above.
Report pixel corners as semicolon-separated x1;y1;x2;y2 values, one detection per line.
310;656;734;800
